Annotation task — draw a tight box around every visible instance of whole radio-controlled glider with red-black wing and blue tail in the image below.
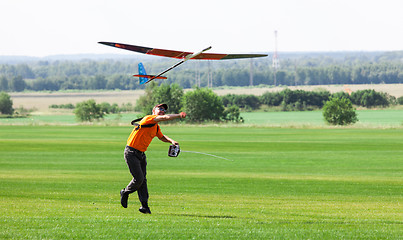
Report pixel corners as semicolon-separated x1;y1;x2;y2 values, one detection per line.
98;42;267;84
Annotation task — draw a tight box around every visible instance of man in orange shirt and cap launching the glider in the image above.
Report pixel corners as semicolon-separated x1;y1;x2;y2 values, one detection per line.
120;104;186;214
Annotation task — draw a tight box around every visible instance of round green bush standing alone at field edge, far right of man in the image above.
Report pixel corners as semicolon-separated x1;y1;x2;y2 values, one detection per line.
323;97;358;125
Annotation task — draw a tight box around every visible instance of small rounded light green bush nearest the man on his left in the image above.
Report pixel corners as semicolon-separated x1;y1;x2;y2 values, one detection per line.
74;99;104;122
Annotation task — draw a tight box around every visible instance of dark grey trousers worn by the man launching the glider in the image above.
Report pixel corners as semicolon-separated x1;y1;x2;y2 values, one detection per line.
125;146;148;202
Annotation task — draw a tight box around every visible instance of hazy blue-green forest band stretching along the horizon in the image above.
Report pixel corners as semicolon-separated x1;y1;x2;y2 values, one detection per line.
0;52;403;91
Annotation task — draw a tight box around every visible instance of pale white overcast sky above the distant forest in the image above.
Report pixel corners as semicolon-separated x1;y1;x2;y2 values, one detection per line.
0;0;403;57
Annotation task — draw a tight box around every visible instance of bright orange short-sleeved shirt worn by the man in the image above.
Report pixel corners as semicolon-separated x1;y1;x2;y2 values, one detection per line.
127;115;164;152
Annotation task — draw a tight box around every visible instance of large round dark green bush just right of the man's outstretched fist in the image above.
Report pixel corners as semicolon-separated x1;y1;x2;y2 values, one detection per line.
183;88;224;122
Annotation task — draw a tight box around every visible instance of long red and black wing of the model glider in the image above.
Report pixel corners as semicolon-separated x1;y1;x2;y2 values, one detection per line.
99;42;267;60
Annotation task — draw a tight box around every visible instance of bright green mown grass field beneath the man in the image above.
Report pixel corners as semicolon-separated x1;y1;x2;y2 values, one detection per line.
0;125;403;239
